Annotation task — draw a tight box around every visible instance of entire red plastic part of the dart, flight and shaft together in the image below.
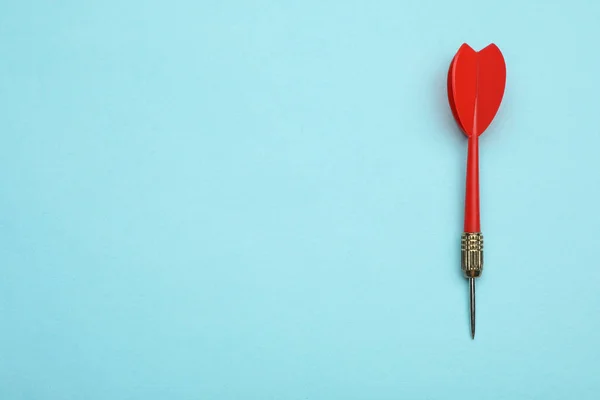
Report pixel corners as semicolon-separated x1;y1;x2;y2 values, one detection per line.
448;43;506;232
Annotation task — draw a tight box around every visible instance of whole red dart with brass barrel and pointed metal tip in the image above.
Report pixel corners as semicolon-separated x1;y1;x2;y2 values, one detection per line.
448;43;506;339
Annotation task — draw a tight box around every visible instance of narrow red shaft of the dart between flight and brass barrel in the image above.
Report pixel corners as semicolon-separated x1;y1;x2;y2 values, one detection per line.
464;135;481;232
